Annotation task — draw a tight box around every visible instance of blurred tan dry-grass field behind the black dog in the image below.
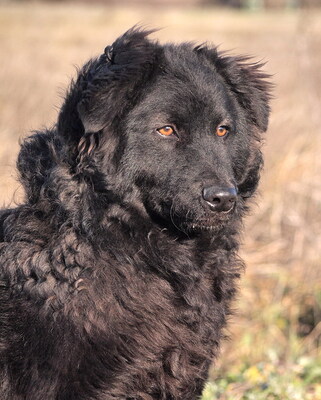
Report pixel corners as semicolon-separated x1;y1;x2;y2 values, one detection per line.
0;0;321;400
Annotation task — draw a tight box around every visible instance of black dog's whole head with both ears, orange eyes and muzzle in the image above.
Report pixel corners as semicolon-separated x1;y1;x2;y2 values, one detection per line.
58;29;270;230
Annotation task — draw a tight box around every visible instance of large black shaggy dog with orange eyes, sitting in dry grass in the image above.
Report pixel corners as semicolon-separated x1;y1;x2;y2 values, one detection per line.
0;29;270;400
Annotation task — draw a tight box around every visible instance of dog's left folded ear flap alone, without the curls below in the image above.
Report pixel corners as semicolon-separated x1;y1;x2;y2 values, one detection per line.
78;28;157;136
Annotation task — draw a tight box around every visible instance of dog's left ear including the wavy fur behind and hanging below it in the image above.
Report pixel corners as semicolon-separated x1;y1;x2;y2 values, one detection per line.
58;27;159;166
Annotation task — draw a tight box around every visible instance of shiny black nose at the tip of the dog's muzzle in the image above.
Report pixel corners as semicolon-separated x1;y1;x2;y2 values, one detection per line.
202;186;237;211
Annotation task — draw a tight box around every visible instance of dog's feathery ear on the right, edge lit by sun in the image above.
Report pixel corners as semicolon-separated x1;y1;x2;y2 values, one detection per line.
194;45;273;132
